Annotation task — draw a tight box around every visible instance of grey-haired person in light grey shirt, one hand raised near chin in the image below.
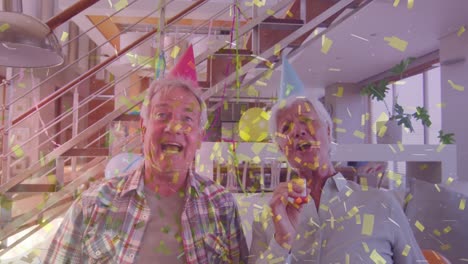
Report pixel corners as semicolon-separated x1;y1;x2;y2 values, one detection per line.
249;57;426;264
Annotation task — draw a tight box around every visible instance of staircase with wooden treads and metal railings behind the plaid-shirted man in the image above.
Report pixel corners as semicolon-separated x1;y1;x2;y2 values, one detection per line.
0;0;371;256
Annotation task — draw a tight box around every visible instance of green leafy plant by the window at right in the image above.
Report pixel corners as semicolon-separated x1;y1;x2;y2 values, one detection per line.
361;57;432;144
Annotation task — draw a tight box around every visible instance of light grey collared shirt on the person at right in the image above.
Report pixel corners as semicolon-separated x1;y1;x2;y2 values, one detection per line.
249;173;427;264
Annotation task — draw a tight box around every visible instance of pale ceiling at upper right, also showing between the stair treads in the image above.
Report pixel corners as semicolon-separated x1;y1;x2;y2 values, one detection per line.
59;0;468;97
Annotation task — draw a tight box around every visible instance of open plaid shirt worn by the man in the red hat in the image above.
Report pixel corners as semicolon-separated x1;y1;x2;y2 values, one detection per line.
44;167;248;264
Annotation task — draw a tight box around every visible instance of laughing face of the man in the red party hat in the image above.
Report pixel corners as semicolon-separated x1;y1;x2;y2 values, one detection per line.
142;87;203;185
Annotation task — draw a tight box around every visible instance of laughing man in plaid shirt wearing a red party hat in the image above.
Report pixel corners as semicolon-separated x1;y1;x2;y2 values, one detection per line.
45;46;248;264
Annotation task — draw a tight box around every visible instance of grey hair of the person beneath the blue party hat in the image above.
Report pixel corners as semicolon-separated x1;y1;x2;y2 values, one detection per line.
269;96;333;142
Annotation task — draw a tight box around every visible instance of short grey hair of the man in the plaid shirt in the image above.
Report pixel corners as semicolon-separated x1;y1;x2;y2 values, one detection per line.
140;78;208;130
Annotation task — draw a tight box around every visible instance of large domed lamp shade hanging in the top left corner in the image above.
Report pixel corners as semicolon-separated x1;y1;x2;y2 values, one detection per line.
0;12;63;68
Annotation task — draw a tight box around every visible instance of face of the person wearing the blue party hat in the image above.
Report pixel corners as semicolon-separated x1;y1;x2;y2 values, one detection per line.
276;100;331;171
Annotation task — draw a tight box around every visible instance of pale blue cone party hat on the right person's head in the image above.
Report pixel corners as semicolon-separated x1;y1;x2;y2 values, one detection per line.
279;53;305;100
